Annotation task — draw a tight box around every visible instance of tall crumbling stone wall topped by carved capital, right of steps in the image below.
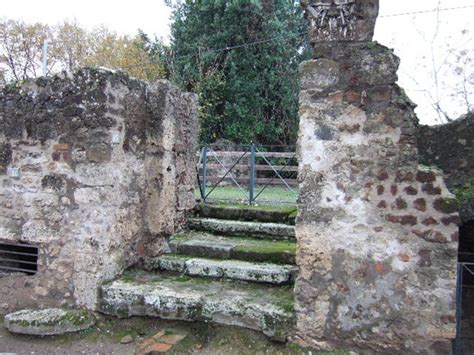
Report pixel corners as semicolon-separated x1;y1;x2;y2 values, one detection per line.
294;0;459;354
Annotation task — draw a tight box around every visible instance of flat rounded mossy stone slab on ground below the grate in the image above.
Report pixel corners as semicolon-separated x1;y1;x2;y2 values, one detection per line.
4;308;96;335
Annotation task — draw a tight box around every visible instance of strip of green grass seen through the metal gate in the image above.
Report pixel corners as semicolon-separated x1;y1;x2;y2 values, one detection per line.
194;186;298;205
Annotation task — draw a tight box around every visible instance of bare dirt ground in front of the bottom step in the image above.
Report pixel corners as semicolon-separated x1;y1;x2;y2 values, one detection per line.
0;317;318;355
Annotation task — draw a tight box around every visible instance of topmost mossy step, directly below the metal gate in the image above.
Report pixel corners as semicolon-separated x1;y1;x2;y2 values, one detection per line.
198;204;297;225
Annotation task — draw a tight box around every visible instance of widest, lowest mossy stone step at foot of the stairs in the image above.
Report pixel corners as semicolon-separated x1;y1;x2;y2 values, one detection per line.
100;272;295;341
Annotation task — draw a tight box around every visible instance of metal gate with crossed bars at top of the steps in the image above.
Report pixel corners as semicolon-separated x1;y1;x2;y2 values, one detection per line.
197;144;298;205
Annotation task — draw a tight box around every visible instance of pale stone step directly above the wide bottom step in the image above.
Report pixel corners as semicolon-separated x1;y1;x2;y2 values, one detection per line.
147;254;297;285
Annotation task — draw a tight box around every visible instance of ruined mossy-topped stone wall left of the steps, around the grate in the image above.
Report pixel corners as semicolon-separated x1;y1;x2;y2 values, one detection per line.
0;70;197;313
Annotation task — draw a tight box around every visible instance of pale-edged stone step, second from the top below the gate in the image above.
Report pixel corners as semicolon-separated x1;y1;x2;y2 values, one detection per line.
188;218;295;240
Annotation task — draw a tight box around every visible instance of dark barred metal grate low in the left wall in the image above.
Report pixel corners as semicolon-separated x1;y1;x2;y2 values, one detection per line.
0;243;39;275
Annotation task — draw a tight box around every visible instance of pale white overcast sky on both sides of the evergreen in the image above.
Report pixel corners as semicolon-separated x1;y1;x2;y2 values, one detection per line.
0;0;474;124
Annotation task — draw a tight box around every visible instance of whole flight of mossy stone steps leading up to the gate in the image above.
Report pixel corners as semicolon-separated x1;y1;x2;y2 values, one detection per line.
100;205;297;341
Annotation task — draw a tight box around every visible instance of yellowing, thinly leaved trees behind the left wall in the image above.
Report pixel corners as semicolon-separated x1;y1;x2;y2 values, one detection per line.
0;20;165;82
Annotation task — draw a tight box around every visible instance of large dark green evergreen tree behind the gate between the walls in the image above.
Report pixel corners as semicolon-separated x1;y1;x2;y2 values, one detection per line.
168;0;309;145
